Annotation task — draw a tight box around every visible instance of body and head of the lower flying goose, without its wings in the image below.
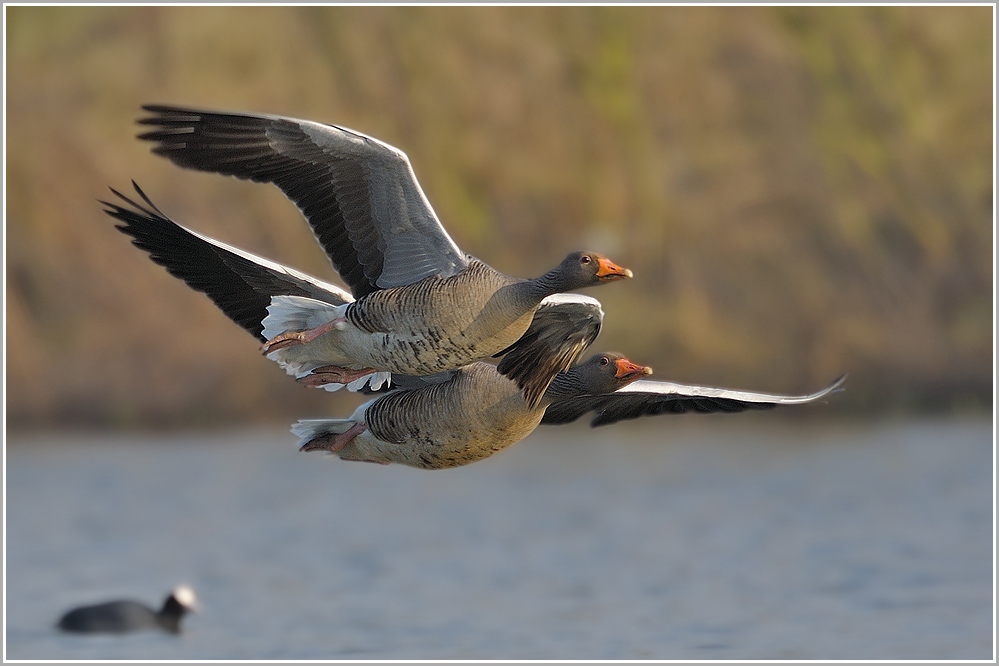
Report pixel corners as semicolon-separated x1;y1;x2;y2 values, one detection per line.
291;353;652;469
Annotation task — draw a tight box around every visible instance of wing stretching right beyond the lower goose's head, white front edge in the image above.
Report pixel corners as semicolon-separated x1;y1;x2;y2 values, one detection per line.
541;375;846;426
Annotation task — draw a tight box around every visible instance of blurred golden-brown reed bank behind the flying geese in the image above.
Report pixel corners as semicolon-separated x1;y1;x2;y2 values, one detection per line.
4;6;994;428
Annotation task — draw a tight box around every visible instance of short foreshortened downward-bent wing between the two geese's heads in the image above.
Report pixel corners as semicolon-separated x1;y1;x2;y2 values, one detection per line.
495;294;604;407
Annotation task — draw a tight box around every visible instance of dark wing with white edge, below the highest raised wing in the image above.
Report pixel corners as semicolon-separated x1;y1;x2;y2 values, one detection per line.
100;182;353;342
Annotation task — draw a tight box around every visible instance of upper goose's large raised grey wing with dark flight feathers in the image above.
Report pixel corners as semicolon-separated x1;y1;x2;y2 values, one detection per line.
139;105;468;298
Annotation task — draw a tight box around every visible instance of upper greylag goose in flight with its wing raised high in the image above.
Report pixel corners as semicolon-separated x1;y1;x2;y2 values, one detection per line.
139;105;631;405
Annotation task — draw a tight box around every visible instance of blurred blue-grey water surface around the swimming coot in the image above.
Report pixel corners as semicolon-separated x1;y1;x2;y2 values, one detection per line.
5;414;994;660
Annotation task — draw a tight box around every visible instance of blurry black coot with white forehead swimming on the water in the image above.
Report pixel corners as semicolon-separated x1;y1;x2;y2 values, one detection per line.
57;585;198;634
